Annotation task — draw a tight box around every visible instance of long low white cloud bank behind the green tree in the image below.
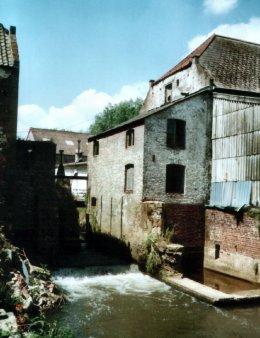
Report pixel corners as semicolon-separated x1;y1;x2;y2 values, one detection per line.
17;82;148;138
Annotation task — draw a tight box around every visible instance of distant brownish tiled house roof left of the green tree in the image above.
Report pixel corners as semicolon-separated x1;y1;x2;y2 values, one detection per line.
27;128;89;155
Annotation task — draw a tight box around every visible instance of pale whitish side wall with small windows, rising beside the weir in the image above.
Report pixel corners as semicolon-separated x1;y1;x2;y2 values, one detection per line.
88;125;144;239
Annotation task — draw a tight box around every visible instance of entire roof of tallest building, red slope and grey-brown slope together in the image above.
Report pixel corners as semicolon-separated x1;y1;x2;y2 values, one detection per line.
152;34;260;92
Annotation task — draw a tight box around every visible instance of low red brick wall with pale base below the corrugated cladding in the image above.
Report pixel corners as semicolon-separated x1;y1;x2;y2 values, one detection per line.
204;209;260;283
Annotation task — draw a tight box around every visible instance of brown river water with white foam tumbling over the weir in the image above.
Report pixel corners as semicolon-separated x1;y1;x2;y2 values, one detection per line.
51;265;260;338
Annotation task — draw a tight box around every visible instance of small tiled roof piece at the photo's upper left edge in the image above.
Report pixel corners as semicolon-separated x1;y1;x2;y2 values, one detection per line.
0;23;19;67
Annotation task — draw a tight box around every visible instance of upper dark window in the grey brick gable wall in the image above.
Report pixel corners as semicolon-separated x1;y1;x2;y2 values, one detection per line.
167;119;186;149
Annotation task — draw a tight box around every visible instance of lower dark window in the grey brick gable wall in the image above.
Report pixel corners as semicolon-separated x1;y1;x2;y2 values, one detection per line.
166;164;185;194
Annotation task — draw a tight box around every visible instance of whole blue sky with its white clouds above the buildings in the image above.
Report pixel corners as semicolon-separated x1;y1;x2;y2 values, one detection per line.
0;0;260;137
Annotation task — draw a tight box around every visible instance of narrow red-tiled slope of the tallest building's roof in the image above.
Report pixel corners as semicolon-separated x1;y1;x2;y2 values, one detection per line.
153;34;215;85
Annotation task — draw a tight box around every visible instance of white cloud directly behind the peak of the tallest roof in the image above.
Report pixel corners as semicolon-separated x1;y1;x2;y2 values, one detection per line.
188;17;260;51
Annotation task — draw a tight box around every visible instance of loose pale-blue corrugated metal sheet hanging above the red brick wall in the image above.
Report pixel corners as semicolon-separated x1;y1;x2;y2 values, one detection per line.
210;181;251;209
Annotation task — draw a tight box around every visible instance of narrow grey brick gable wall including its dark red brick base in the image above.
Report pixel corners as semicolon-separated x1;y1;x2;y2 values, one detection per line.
143;93;212;248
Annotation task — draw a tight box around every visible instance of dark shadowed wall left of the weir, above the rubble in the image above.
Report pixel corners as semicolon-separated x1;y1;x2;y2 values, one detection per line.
13;141;59;259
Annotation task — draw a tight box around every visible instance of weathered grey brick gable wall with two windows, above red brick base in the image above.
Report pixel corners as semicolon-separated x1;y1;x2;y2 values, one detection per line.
143;93;212;204
